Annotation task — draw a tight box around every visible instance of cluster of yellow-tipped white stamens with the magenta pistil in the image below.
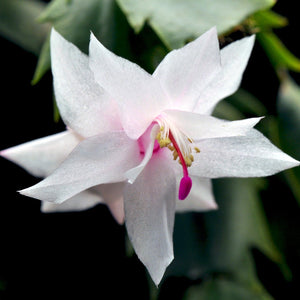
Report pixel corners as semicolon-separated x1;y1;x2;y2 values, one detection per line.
156;118;200;200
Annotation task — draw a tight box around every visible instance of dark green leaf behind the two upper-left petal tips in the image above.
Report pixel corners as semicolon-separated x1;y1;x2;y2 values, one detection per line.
33;0;130;83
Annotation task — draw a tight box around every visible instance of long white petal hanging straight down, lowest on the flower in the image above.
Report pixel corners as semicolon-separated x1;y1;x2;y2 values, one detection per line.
124;155;176;285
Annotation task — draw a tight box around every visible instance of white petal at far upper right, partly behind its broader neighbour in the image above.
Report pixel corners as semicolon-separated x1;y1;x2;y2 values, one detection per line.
194;36;255;114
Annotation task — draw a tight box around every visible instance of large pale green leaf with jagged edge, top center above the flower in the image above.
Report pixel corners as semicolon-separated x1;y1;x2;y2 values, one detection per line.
117;0;275;49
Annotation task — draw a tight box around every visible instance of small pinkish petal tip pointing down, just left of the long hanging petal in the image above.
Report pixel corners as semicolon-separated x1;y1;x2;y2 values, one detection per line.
91;182;125;224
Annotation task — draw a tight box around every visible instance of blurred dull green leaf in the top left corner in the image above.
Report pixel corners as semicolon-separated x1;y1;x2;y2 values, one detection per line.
0;0;49;54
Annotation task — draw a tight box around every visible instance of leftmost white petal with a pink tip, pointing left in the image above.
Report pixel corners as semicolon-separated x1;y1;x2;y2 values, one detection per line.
0;131;80;177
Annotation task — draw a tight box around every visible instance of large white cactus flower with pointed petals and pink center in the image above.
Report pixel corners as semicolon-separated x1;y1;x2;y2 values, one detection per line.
1;28;299;284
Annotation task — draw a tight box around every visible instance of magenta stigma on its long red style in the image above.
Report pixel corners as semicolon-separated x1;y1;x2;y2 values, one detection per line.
169;131;192;200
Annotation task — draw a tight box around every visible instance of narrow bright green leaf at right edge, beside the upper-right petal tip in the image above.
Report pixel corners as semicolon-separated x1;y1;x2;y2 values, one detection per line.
257;31;300;72
